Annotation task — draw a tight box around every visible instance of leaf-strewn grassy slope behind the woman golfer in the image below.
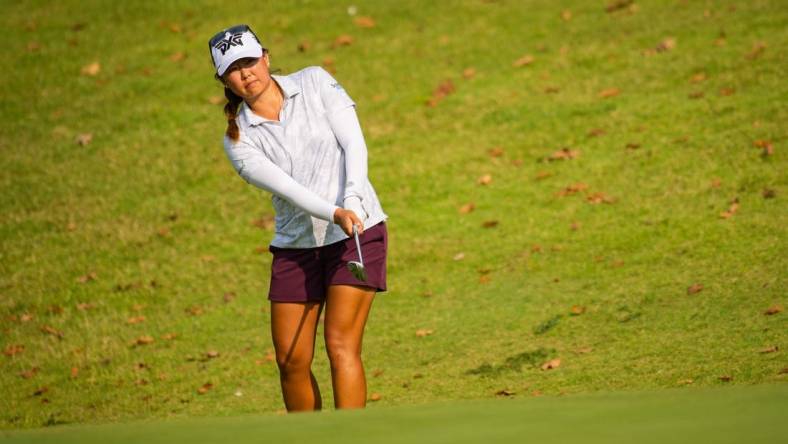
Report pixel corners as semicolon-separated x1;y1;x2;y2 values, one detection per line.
0;0;788;429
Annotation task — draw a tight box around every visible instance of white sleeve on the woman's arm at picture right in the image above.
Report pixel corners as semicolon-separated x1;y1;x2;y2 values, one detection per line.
327;106;367;202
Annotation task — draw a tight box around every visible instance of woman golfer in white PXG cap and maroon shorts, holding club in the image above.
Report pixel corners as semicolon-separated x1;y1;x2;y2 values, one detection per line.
209;25;387;412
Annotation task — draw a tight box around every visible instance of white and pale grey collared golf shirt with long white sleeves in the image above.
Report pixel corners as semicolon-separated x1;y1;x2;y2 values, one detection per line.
224;66;388;248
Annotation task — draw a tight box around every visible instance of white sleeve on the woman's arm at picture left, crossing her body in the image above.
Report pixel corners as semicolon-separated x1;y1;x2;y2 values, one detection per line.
224;137;339;222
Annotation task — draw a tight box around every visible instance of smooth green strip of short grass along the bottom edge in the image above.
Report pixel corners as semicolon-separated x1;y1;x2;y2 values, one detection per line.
0;385;788;444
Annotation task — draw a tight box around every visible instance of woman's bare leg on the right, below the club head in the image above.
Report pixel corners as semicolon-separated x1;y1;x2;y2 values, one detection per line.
324;285;375;409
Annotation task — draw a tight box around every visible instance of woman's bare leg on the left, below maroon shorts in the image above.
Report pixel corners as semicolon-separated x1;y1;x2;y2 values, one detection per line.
271;301;323;412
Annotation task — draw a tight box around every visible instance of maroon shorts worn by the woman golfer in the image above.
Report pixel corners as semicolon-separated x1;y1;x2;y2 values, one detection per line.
268;221;388;302
